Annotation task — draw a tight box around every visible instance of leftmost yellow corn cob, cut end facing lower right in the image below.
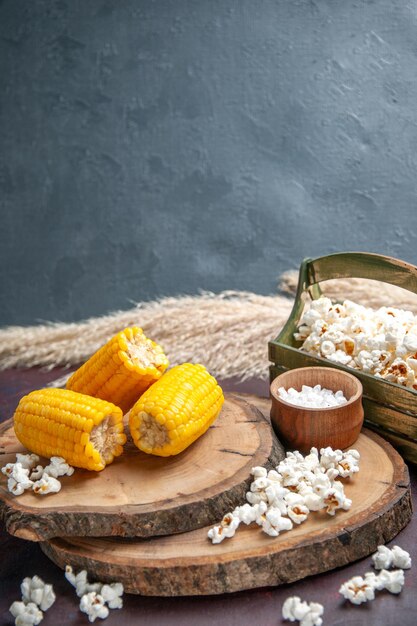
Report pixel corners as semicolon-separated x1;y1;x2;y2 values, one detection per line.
14;389;126;471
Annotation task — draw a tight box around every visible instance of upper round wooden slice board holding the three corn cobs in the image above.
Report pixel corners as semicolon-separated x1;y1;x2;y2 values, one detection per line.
0;395;284;541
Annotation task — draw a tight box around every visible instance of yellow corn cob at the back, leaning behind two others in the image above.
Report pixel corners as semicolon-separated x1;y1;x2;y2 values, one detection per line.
67;326;168;413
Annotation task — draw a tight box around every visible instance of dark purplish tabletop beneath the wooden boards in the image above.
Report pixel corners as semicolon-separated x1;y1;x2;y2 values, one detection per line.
0;369;417;626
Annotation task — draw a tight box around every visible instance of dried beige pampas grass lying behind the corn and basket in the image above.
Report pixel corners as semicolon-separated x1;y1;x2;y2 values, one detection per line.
0;272;417;380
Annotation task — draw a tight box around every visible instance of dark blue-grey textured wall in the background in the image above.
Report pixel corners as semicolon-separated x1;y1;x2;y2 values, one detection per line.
0;0;417;324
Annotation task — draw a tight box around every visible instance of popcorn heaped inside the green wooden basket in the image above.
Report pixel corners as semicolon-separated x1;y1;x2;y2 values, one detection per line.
294;296;417;389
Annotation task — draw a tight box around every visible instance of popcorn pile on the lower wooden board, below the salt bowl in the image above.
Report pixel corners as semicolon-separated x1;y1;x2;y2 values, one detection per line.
208;448;360;543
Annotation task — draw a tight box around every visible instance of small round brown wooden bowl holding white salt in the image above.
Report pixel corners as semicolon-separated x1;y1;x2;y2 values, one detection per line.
270;367;363;452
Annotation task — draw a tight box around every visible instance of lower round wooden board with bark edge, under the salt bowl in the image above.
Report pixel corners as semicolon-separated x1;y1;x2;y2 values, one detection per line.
41;399;412;596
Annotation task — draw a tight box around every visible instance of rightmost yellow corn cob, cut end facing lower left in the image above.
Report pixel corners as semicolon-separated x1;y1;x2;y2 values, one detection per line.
129;363;224;456
